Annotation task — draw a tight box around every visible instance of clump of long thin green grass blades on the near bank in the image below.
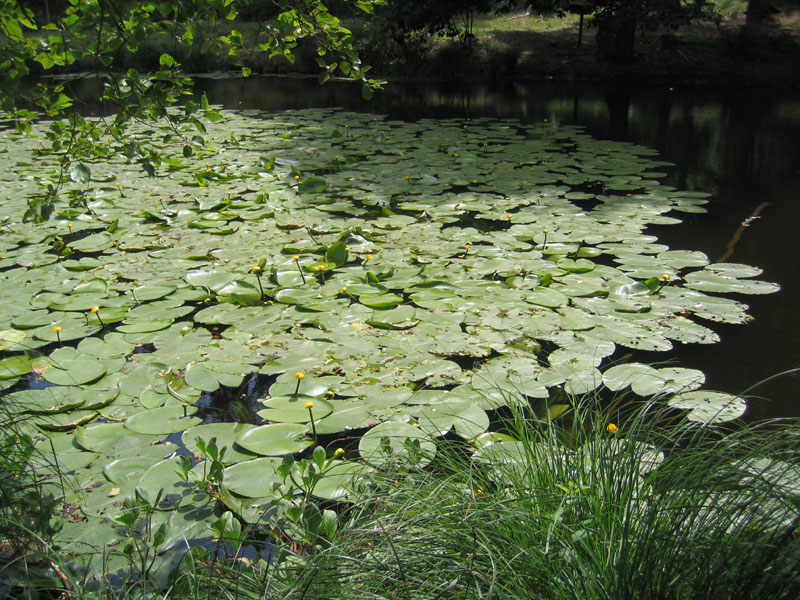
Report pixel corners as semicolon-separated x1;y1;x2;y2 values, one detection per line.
290;402;800;599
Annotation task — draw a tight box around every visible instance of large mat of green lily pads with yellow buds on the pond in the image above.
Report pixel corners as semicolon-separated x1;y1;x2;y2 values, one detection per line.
0;110;778;571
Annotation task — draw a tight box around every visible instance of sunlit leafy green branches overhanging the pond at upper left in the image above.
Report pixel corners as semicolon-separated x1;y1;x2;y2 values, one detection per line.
0;0;383;220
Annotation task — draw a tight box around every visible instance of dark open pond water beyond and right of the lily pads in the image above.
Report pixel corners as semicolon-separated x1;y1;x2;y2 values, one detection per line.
196;77;800;418
